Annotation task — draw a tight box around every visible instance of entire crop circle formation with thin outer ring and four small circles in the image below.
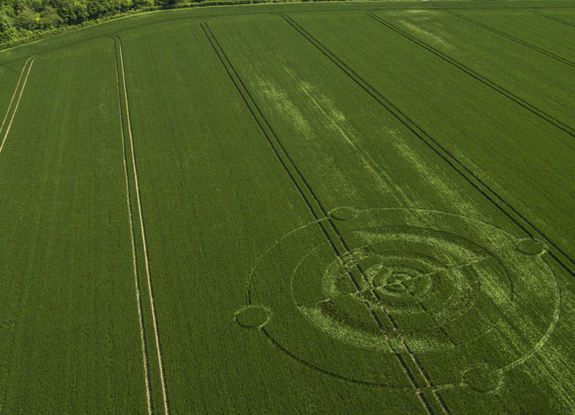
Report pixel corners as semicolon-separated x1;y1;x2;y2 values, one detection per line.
235;208;560;393
